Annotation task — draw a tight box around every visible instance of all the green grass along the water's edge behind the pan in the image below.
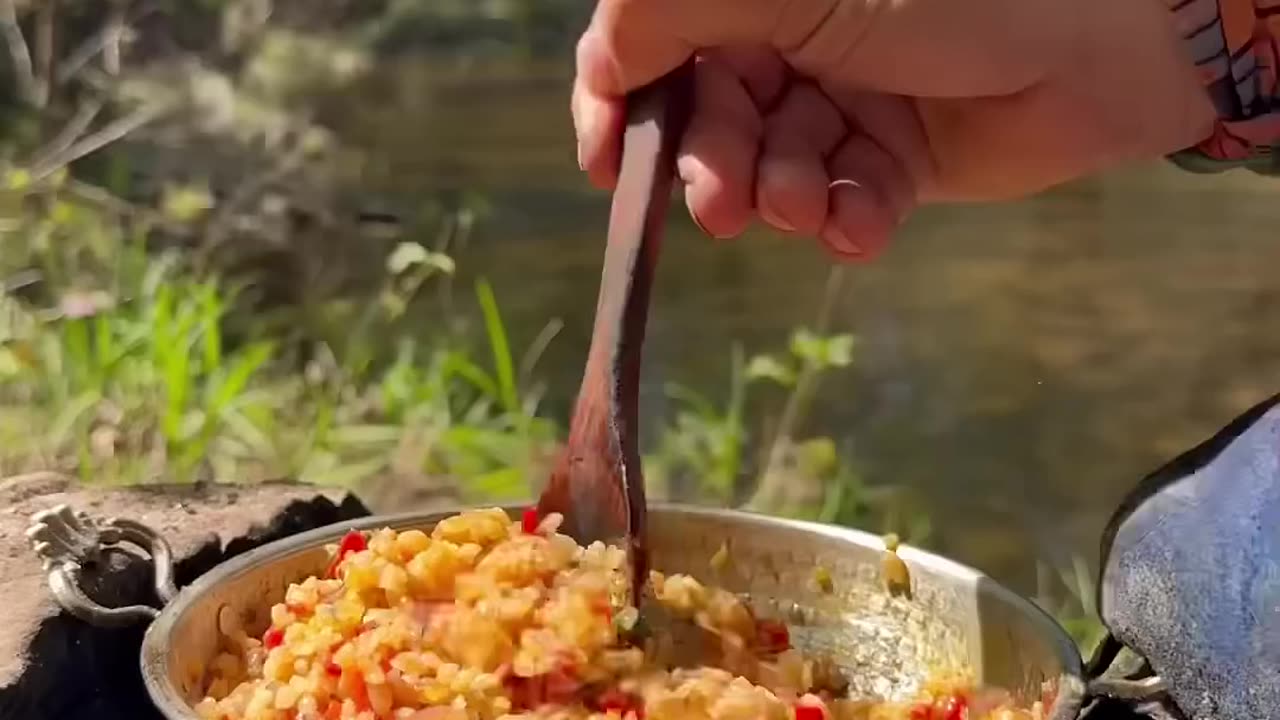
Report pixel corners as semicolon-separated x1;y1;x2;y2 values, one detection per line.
0;162;1102;652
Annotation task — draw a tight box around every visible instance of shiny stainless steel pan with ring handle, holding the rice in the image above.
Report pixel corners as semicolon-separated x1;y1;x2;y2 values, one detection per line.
29;505;1087;720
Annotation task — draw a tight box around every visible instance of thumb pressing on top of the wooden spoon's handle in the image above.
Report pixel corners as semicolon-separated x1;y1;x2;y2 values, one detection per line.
577;0;839;97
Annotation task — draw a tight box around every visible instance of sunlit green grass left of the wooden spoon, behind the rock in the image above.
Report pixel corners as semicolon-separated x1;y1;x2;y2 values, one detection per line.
0;170;557;498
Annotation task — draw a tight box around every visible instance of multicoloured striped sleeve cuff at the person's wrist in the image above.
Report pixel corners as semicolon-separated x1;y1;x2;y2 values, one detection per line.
1166;0;1280;176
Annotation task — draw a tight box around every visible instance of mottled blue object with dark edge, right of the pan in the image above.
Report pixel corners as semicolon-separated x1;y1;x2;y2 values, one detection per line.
1098;396;1280;720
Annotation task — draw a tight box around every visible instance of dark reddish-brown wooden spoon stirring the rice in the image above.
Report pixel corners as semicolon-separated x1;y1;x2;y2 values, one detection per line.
538;65;692;600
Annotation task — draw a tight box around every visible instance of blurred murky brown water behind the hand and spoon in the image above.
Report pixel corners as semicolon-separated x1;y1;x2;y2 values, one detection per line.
314;56;1280;589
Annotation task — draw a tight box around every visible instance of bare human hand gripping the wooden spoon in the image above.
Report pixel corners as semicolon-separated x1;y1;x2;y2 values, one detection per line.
572;0;1215;260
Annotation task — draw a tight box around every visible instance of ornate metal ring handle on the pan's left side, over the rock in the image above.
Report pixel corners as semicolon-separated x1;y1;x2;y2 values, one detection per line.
27;505;178;628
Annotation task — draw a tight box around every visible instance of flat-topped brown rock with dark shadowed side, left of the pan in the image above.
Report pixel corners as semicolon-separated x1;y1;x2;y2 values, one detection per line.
0;473;369;720
